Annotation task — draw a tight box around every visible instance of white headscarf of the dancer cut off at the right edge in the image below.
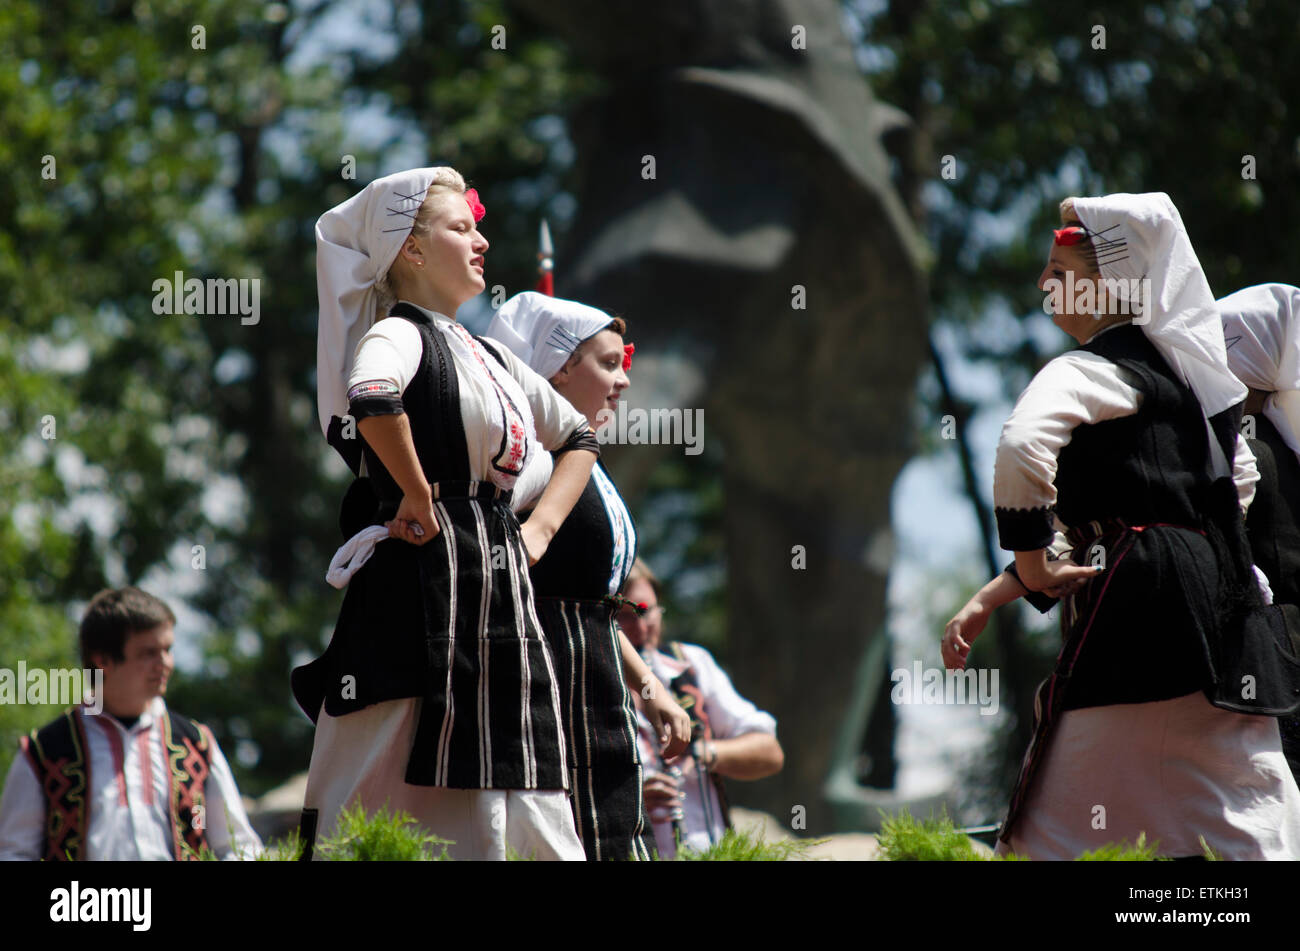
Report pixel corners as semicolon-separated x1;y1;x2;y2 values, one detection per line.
1218;285;1300;456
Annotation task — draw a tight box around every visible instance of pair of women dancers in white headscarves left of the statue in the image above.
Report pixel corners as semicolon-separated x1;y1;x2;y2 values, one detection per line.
293;168;780;860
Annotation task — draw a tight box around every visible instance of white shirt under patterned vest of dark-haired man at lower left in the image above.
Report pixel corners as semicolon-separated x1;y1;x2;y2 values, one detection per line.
0;696;261;861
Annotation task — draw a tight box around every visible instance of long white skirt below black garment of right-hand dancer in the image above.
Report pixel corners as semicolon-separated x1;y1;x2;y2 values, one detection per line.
997;692;1300;860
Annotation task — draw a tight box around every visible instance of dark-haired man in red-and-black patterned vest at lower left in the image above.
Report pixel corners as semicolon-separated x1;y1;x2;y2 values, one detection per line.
0;587;261;861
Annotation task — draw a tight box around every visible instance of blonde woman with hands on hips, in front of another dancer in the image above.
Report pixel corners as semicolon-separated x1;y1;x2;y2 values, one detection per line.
293;168;599;860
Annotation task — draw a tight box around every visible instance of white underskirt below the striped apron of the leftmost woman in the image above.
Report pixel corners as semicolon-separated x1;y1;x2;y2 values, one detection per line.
304;698;586;861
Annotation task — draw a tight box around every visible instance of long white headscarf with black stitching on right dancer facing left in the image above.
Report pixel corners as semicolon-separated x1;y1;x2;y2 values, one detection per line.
1074;191;1247;472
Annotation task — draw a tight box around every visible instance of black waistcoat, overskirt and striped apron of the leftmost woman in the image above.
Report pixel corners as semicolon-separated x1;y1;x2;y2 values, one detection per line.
291;303;566;805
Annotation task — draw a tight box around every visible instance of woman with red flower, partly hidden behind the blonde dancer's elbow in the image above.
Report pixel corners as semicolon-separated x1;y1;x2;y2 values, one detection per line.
488;291;690;861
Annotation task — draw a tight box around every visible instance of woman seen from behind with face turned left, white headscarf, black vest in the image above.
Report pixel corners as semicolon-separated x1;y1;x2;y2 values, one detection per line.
943;192;1300;859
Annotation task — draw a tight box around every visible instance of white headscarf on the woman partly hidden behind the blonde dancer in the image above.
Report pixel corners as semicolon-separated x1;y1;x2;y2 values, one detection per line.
485;291;614;379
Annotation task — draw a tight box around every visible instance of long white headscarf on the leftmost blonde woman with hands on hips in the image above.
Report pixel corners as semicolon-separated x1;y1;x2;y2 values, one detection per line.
316;166;457;434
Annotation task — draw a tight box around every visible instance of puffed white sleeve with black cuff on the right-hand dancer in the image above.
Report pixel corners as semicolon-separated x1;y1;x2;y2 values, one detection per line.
993;351;1141;551
